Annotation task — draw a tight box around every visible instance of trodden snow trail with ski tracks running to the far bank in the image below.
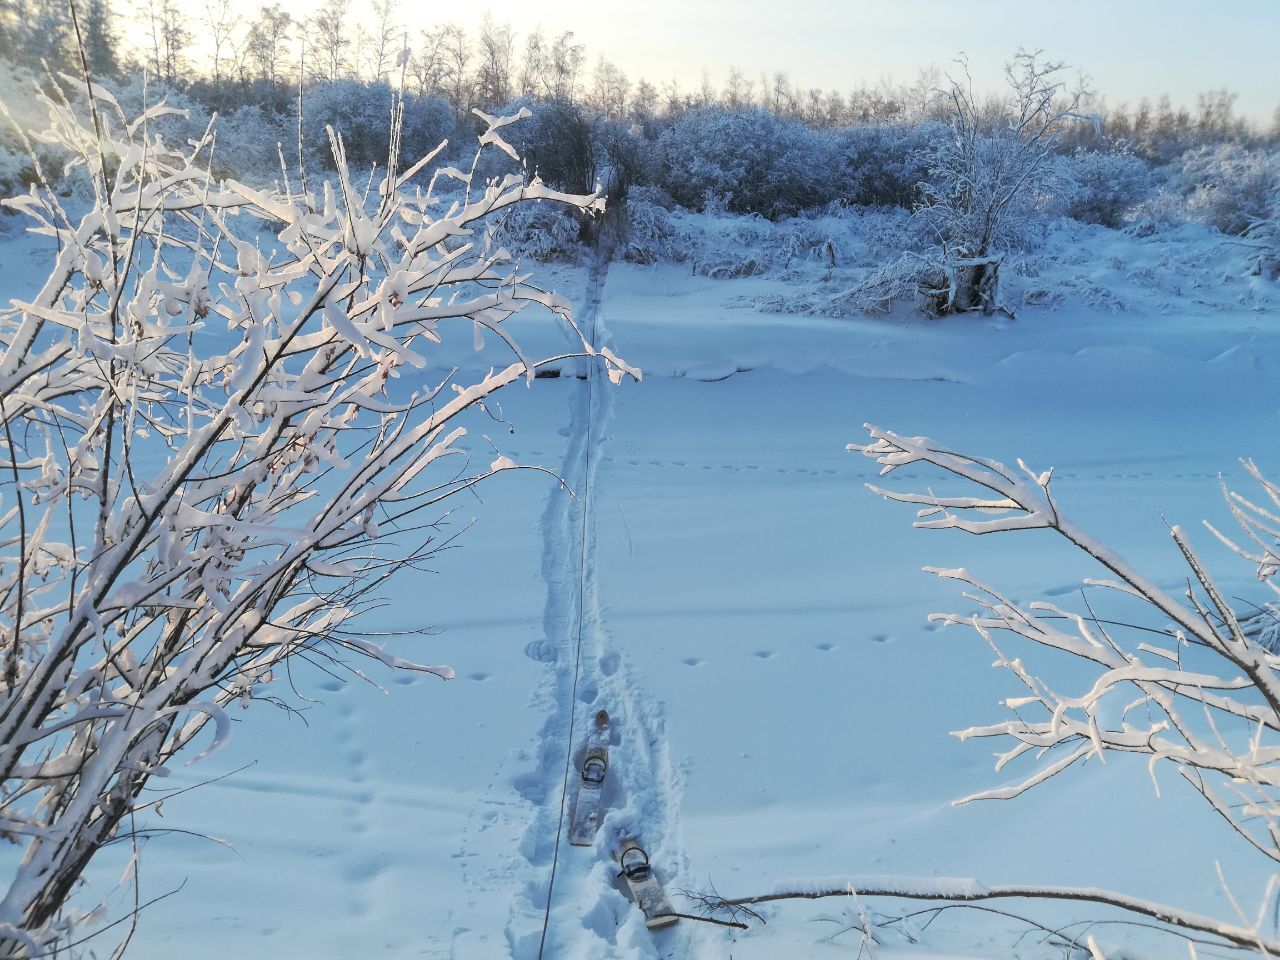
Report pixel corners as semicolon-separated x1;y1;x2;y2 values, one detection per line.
507;241;690;960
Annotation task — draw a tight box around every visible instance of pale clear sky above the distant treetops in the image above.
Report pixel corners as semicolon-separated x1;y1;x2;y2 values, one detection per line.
170;0;1280;123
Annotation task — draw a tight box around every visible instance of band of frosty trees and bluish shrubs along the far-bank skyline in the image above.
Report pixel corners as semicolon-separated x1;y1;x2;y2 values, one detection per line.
0;0;1280;253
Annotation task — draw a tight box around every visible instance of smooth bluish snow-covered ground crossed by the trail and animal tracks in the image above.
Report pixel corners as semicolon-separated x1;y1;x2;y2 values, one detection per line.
0;212;1280;960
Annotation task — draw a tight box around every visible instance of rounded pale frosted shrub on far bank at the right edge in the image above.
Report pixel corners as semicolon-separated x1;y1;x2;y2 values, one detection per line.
1171;143;1280;237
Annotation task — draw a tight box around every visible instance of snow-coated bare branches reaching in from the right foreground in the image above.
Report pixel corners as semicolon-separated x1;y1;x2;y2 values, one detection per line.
839;425;1280;955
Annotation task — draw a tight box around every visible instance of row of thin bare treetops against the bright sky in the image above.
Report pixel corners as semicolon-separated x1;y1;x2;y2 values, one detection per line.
0;0;1280;152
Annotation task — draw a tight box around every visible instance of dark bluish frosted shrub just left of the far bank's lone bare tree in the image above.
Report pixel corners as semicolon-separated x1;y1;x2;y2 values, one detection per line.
837;123;947;207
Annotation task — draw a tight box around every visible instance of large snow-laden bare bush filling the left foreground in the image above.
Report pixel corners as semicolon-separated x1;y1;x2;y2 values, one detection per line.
0;75;637;959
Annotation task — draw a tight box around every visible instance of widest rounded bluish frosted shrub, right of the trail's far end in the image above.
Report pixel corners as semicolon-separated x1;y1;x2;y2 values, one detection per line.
655;106;844;220
